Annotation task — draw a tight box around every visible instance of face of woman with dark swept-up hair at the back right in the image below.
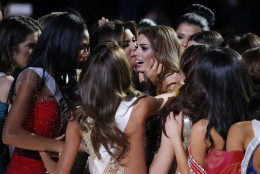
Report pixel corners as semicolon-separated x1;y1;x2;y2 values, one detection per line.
176;23;201;50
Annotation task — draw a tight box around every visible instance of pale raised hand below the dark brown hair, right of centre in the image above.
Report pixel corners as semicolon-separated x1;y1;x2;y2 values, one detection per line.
165;112;183;145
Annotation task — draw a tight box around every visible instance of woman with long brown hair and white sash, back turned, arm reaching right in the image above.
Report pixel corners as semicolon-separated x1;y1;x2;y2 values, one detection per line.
37;42;178;174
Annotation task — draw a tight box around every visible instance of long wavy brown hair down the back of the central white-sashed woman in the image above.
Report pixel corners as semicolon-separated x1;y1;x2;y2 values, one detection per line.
77;41;143;160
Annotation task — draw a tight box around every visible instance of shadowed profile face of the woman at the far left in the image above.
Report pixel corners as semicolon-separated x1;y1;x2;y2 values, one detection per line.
13;32;39;68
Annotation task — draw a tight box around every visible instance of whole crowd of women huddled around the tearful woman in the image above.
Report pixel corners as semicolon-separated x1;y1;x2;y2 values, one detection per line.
0;4;260;174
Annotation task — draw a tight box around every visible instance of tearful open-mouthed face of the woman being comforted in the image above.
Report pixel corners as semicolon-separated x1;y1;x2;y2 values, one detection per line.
136;34;155;72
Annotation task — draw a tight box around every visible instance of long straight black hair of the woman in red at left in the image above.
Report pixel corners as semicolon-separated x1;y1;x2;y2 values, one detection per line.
9;13;87;103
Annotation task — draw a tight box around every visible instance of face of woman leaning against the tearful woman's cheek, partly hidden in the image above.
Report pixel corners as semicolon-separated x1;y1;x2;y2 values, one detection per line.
123;29;137;67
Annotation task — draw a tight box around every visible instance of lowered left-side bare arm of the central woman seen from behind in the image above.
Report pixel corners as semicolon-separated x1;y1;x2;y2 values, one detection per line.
40;121;82;174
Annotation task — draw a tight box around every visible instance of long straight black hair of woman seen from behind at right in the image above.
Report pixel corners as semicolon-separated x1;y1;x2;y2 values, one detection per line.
194;48;253;149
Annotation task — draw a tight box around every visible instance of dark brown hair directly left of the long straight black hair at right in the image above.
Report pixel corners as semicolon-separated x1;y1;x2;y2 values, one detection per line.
162;44;214;133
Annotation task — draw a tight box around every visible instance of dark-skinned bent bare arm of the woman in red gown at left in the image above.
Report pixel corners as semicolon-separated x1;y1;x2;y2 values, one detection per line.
3;70;64;152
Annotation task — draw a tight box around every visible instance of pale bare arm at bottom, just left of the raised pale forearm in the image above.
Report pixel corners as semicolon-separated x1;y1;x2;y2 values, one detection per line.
149;133;174;174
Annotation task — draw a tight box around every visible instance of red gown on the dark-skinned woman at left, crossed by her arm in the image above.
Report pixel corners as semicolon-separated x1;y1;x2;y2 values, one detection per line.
6;95;61;174
